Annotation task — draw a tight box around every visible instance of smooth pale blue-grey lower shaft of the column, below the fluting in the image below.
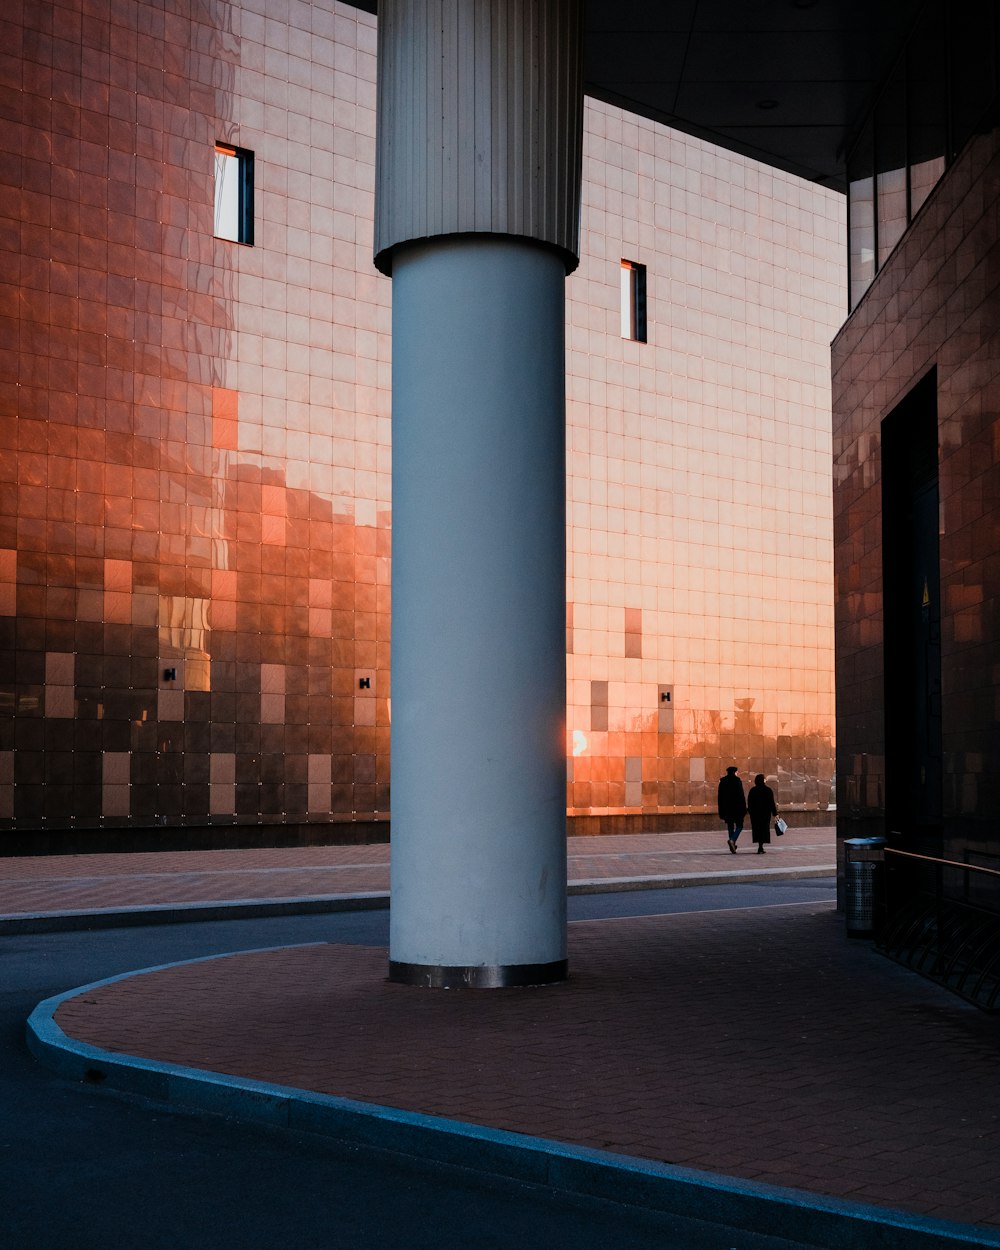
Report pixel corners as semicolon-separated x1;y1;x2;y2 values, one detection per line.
390;235;566;985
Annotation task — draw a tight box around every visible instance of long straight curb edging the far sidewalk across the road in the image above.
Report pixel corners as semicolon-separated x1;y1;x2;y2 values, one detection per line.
0;864;836;936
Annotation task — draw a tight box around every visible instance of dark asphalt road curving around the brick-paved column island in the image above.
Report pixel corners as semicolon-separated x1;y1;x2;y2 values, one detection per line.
0;881;833;1250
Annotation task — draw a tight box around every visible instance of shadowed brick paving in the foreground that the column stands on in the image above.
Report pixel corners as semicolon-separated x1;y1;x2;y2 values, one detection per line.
56;904;1000;1226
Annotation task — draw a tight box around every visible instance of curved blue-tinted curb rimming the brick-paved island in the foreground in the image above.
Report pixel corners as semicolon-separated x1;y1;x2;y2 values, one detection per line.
26;944;1000;1250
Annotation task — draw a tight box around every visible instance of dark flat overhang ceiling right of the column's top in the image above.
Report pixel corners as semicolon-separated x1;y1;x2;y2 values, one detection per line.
359;0;923;190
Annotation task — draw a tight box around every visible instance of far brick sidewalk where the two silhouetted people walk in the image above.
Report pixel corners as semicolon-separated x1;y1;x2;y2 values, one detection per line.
0;828;835;919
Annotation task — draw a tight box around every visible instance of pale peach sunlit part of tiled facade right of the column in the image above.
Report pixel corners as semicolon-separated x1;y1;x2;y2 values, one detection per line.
568;104;844;828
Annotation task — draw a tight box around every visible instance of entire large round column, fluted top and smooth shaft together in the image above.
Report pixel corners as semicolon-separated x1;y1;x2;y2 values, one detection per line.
375;0;583;988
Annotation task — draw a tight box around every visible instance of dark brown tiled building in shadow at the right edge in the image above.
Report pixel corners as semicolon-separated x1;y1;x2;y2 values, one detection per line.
833;3;1000;995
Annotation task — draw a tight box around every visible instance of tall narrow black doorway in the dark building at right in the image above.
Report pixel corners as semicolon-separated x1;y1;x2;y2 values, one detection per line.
883;370;943;855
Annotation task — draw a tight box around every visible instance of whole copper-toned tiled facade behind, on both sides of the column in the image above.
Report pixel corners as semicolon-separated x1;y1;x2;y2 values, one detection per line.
0;0;844;838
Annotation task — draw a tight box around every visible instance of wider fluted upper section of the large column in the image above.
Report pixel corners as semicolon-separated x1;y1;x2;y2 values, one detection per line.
375;0;583;274
